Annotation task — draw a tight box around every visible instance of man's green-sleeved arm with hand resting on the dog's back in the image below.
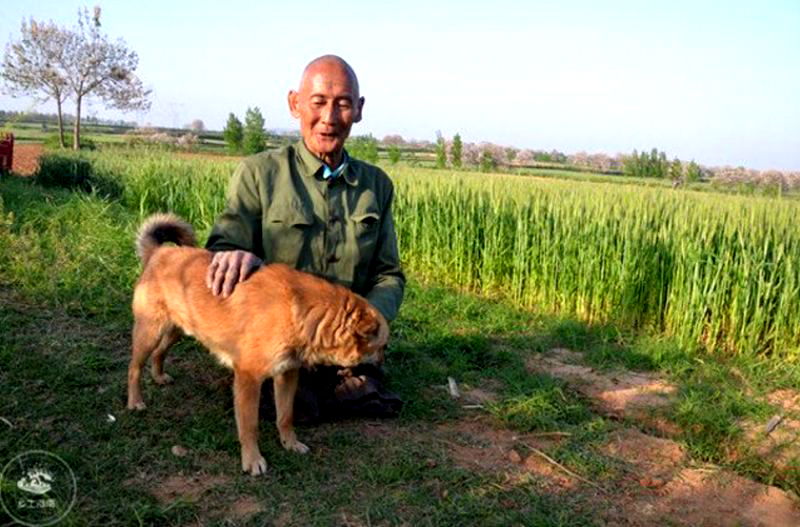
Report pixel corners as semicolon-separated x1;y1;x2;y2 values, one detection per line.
206;162;263;297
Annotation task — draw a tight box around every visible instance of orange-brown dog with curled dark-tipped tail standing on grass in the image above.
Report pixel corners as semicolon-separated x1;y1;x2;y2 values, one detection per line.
128;214;389;475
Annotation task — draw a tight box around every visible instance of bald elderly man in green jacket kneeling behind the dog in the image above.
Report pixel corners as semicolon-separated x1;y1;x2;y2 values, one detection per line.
206;55;405;419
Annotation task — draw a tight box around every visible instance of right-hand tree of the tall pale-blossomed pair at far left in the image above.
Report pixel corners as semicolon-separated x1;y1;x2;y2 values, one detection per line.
60;8;150;150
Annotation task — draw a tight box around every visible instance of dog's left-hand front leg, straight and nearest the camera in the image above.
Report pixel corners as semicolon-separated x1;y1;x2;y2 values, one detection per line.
233;369;267;476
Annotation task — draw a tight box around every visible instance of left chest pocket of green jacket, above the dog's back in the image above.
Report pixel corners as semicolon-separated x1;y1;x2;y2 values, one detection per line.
264;207;314;267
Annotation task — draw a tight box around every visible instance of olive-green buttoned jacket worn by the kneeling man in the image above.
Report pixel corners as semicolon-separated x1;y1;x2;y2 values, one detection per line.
206;140;405;320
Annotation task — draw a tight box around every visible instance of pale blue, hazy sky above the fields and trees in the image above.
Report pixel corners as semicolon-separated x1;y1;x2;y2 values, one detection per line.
0;0;800;170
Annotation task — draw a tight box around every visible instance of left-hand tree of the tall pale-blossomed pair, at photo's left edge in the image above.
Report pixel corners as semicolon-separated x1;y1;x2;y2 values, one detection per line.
0;18;71;148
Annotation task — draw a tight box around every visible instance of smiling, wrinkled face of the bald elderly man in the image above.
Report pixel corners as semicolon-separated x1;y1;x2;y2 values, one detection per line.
289;62;364;164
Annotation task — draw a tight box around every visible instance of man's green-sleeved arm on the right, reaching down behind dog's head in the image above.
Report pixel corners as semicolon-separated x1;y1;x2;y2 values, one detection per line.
366;187;406;321
